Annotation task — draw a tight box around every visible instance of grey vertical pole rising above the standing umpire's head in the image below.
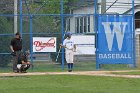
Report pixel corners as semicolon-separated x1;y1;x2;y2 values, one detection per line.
14;0;18;34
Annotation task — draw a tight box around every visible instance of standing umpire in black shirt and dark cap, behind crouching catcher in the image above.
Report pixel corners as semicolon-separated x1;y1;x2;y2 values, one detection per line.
10;32;22;72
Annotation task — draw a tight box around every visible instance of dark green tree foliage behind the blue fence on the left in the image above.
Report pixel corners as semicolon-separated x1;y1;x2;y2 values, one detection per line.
0;0;77;66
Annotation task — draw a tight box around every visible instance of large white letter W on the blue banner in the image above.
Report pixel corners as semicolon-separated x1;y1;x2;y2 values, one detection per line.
102;22;127;51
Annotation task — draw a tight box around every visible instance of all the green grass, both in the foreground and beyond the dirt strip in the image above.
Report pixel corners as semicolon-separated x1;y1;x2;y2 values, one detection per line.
0;62;140;93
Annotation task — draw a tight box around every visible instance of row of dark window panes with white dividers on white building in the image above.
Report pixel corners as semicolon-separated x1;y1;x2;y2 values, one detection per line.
75;16;90;33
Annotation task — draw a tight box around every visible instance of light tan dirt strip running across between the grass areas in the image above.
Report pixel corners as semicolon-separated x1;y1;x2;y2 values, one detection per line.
0;70;140;78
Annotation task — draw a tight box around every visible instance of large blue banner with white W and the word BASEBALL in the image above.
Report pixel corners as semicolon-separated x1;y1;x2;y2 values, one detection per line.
96;15;133;64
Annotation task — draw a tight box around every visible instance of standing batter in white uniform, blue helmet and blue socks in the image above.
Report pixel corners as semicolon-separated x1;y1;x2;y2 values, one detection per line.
60;32;76;72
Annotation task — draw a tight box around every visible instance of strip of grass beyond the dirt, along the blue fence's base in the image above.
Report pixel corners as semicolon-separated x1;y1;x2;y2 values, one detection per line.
0;62;135;73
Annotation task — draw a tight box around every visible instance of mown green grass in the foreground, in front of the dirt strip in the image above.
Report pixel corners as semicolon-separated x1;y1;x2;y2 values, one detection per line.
0;75;140;93
